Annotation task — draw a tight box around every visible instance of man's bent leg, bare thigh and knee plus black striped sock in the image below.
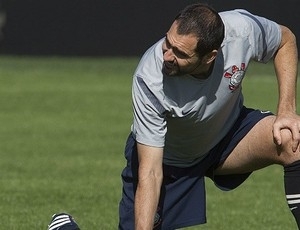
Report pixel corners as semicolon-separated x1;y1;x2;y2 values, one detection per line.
215;116;300;229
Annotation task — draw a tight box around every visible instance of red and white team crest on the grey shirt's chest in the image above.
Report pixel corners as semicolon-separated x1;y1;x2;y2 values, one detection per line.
224;63;246;91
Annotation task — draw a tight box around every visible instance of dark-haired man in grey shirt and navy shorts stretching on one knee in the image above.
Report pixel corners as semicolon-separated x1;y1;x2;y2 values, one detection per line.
119;4;300;230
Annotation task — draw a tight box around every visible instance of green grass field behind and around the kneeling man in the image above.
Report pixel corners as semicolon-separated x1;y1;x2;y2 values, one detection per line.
0;56;299;230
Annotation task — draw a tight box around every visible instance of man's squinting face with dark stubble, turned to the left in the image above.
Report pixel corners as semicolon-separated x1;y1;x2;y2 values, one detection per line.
162;21;201;76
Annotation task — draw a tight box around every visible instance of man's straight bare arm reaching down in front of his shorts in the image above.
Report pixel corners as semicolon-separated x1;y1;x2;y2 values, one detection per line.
134;143;163;230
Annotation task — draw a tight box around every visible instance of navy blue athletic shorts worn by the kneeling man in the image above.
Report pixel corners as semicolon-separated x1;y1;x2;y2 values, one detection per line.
119;107;272;230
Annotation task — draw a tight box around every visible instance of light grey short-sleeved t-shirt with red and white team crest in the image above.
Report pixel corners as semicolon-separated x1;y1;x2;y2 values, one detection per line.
132;10;281;167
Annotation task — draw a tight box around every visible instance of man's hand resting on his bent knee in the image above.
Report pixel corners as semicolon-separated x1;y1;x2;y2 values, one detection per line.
273;113;300;152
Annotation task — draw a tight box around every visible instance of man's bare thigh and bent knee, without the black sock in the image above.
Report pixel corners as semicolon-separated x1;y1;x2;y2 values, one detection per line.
215;116;300;175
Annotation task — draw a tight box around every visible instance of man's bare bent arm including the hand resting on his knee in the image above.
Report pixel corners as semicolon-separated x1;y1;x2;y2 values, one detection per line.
273;26;300;152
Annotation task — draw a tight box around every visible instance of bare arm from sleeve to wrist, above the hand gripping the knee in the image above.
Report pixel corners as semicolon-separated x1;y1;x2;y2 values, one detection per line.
274;27;298;115
